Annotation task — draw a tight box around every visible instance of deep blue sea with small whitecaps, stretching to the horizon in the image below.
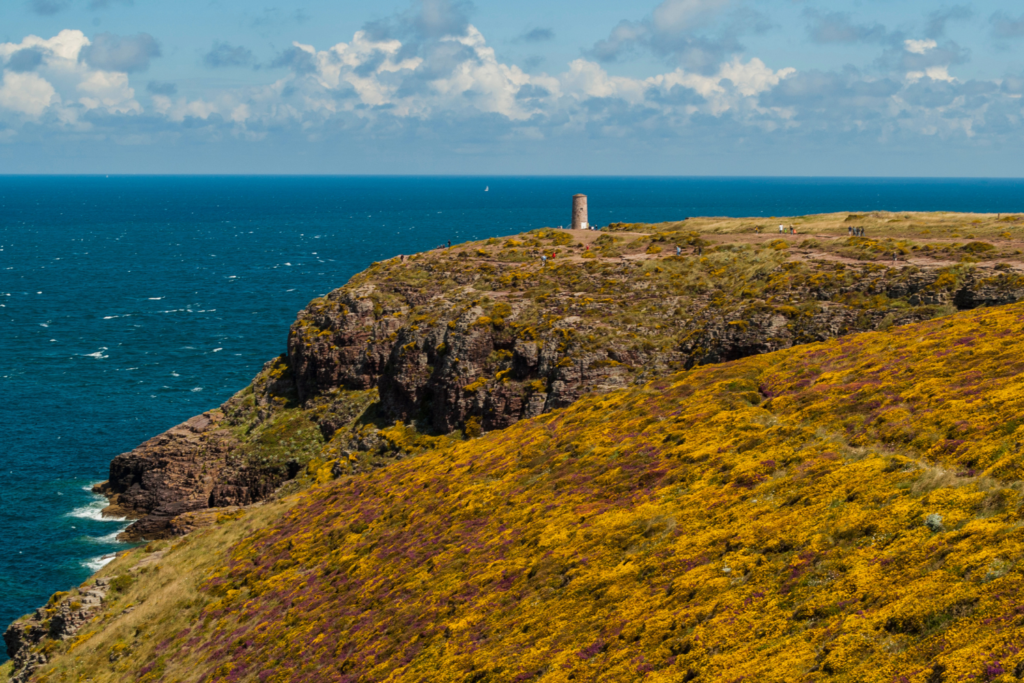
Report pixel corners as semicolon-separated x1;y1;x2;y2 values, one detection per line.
0;176;1024;657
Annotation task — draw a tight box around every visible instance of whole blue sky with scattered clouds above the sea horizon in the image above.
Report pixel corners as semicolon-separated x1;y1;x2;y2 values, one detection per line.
0;0;1024;176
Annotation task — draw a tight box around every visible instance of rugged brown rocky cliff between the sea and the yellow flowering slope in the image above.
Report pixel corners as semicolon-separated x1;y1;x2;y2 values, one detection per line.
99;230;1024;539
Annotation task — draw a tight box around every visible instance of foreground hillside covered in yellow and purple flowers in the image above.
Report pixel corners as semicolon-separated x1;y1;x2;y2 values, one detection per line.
28;305;1024;682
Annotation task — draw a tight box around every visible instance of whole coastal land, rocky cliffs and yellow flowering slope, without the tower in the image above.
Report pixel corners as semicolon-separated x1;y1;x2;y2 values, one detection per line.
6;212;1024;681
